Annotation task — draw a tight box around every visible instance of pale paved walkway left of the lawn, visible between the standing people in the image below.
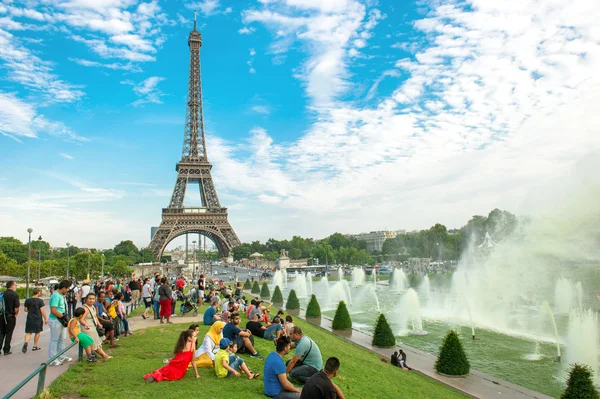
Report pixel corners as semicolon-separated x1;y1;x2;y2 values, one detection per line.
0;300;202;399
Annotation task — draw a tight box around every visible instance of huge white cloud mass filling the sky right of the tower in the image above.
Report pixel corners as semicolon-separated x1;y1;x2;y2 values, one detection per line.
209;0;600;238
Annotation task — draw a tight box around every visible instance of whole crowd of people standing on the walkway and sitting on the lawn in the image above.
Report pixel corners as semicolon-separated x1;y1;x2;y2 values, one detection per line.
0;273;410;399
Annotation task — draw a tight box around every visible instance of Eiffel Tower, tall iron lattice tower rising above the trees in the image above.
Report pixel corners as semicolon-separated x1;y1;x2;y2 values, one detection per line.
150;16;241;259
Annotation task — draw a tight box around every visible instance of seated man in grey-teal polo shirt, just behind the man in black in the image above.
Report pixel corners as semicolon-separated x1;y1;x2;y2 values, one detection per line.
286;326;323;384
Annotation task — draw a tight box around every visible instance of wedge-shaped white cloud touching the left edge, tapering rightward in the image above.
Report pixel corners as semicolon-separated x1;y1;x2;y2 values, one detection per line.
0;92;88;142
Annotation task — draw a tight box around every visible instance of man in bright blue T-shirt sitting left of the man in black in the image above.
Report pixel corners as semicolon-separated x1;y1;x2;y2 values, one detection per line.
263;336;302;399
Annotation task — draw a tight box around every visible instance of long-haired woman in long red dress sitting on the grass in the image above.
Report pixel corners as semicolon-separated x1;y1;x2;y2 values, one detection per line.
144;330;200;383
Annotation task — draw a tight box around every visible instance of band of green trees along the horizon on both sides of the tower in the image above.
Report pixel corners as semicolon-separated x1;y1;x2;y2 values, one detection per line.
0;209;518;279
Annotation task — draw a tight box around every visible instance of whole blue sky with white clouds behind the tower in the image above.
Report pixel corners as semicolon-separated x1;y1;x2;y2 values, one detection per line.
0;0;600;247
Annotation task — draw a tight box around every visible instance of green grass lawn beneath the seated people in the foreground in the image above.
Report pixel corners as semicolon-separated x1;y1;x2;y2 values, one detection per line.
41;317;465;399
